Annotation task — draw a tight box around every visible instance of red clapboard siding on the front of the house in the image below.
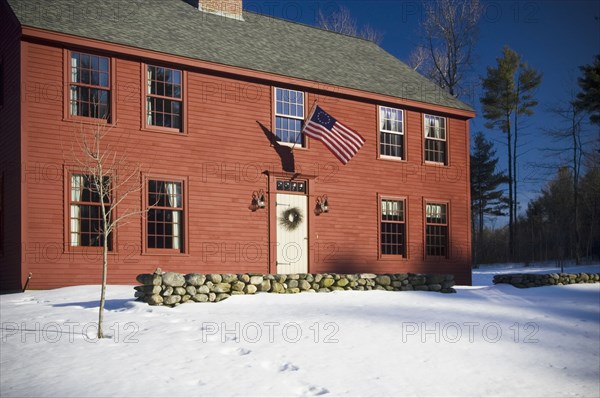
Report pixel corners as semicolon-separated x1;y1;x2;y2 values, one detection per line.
0;31;470;288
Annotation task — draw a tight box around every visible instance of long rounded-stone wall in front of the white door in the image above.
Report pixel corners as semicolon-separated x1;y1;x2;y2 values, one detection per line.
135;268;455;306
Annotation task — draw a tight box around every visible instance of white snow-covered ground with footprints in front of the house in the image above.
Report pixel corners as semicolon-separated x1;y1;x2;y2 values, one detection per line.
0;266;600;397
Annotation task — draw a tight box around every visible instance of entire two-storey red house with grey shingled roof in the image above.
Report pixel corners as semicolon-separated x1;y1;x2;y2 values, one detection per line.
0;0;474;290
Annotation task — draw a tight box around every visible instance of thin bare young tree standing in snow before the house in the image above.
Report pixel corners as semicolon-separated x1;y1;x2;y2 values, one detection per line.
72;123;147;339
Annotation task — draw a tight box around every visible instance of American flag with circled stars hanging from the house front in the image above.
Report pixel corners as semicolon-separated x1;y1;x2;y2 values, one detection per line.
302;105;365;164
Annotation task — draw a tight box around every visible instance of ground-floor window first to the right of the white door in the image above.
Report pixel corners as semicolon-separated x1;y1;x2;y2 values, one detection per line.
379;199;406;257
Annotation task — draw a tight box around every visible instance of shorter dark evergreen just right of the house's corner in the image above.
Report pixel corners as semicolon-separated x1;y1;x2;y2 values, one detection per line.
471;132;508;263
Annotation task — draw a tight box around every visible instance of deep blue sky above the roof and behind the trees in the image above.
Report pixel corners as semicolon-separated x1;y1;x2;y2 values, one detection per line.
244;0;600;222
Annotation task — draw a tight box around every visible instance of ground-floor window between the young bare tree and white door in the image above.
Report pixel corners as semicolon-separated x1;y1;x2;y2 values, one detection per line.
146;180;184;253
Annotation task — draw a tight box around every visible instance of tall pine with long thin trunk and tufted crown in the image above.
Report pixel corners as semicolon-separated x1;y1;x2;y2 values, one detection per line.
480;47;542;260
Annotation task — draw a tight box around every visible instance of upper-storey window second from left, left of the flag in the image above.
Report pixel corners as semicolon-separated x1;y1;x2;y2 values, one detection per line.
146;65;183;131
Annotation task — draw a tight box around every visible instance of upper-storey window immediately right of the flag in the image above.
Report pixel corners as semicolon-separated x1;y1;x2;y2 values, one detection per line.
379;106;404;159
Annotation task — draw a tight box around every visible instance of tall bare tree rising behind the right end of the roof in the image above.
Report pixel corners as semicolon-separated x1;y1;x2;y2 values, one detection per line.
409;0;482;97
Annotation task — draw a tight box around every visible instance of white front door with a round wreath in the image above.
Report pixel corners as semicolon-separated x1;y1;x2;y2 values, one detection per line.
275;193;308;274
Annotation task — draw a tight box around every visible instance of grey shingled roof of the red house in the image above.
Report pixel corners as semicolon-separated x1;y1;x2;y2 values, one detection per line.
7;0;473;111
